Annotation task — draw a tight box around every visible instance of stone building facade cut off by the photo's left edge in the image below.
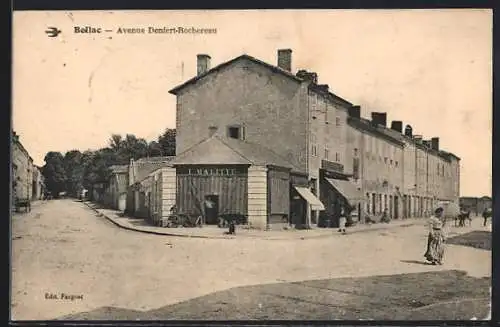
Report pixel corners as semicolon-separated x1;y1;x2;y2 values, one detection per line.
11;132;34;201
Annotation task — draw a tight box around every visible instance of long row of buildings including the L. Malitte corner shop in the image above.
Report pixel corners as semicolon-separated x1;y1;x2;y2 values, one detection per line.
96;49;460;228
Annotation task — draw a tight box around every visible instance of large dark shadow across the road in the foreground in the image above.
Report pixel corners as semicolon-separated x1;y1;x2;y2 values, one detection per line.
60;270;491;320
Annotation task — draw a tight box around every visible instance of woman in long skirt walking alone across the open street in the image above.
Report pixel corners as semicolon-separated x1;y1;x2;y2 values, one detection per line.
424;207;445;265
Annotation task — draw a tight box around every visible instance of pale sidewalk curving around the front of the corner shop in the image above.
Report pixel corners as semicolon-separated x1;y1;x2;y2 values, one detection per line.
83;201;432;240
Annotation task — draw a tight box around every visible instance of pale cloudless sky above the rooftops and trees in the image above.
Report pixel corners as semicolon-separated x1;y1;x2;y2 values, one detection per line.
12;9;493;196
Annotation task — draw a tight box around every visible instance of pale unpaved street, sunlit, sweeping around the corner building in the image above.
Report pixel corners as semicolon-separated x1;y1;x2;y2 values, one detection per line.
12;199;491;320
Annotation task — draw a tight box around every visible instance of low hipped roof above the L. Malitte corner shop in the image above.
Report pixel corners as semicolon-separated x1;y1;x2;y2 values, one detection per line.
172;135;300;171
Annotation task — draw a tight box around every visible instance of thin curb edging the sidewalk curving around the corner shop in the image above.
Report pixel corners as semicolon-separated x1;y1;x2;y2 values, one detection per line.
82;202;426;241
